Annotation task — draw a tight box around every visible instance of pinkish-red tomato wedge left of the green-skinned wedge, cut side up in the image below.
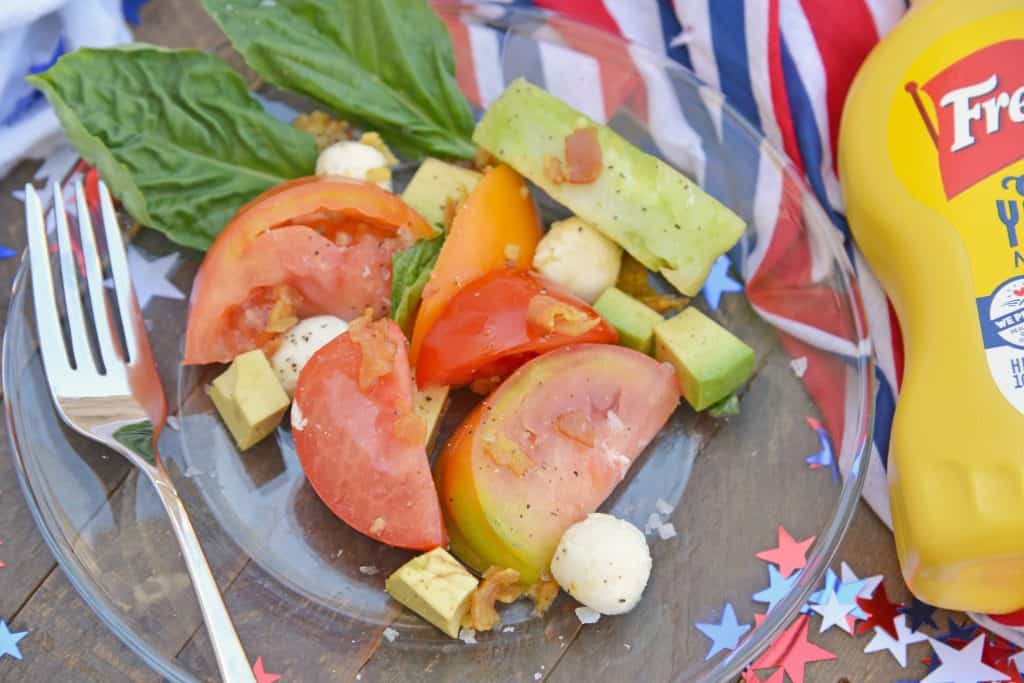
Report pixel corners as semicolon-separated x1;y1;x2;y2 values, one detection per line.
292;317;446;550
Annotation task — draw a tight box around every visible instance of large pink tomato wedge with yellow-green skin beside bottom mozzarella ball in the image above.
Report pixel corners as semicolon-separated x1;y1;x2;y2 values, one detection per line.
434;344;680;585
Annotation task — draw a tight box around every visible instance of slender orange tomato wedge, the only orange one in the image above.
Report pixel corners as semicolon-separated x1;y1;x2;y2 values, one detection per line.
410;166;541;365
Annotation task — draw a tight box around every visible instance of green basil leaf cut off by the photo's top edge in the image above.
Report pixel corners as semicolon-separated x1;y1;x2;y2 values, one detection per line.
202;0;475;159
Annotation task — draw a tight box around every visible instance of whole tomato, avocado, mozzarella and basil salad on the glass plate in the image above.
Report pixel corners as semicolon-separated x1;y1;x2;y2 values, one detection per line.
33;0;755;638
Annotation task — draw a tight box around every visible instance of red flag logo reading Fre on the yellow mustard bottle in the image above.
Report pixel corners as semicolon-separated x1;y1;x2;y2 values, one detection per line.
907;40;1024;199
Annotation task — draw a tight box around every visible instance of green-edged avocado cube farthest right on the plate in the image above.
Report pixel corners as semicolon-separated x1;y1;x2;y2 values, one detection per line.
654;306;754;411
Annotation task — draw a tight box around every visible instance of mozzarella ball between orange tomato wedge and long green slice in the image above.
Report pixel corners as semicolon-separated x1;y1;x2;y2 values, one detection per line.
534;217;623;303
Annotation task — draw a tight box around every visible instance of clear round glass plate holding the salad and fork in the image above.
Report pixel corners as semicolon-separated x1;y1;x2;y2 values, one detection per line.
3;4;872;682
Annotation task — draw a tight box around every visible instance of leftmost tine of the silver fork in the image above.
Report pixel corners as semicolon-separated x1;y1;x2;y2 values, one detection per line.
25;183;71;378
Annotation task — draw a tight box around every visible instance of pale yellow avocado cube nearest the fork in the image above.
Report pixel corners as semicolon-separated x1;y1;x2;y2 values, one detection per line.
210;349;290;451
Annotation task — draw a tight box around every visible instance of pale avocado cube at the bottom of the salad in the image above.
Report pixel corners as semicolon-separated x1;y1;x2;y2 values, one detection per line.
384;548;478;638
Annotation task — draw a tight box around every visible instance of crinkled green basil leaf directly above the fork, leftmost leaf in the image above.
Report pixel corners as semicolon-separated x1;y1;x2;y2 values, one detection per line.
28;45;316;249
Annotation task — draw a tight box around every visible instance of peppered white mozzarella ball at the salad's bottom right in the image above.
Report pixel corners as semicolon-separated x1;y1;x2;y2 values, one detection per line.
551;512;651;614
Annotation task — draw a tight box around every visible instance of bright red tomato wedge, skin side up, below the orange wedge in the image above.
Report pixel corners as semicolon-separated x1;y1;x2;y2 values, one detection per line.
416;268;618;387
